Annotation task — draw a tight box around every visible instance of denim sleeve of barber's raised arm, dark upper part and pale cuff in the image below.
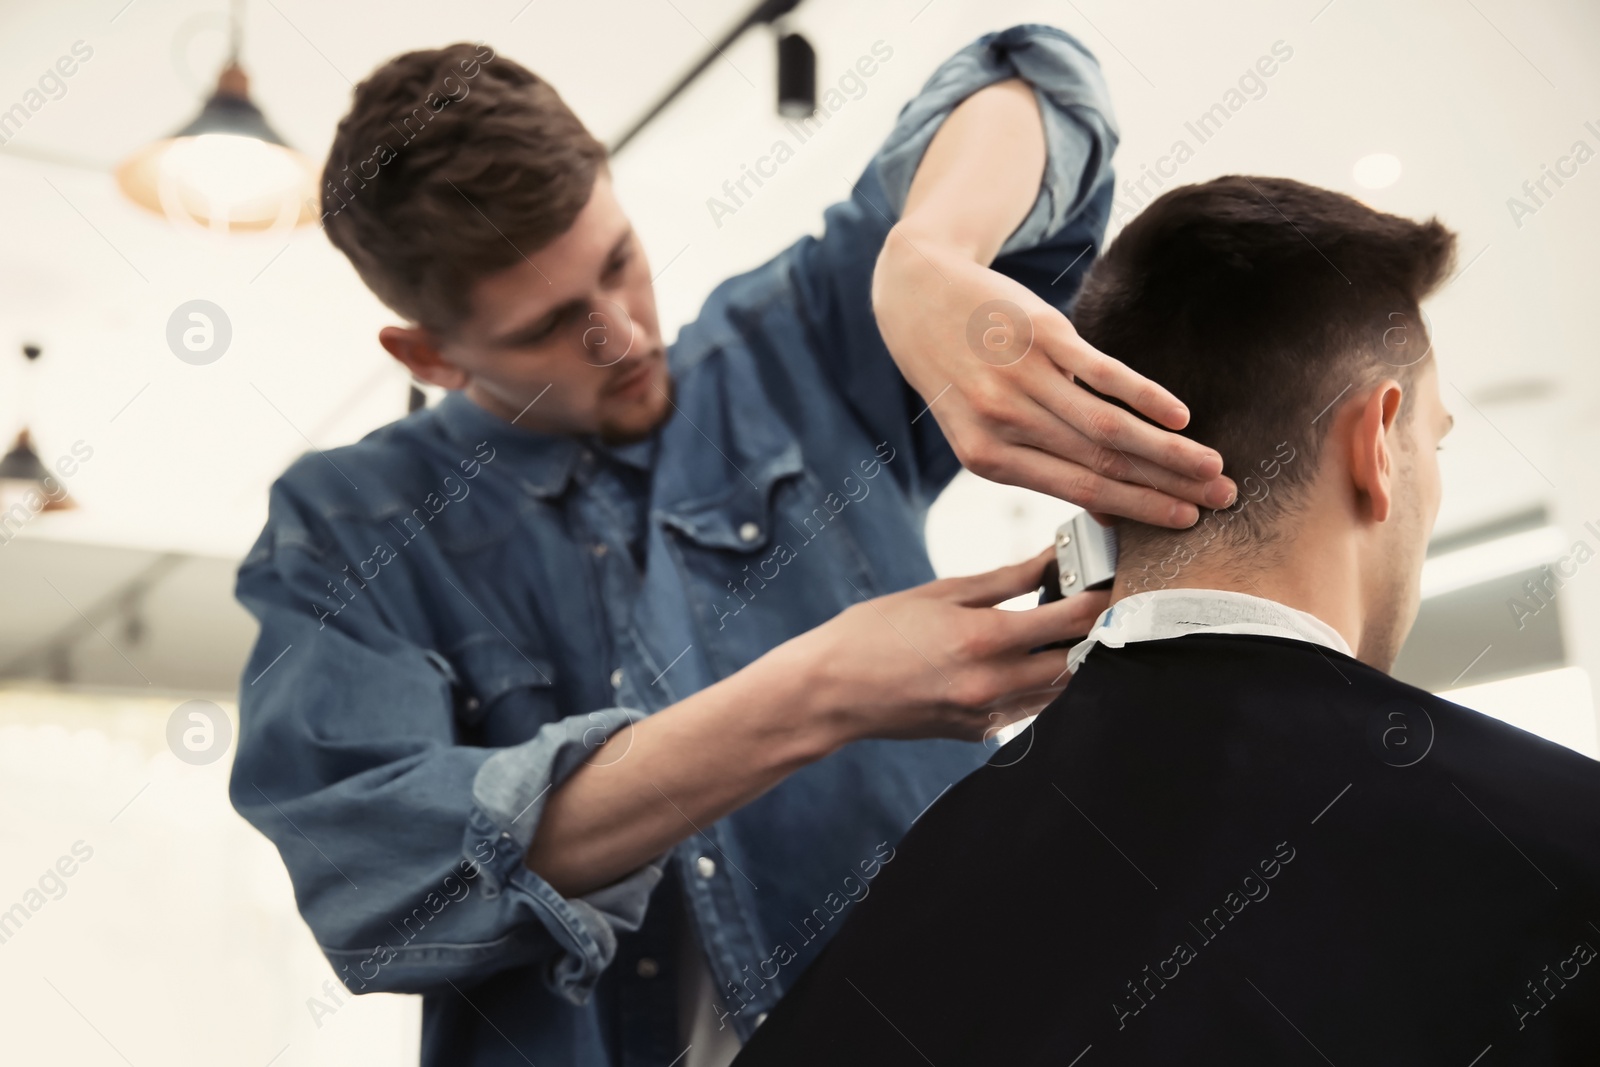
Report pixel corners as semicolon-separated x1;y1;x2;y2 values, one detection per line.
786;26;1117;506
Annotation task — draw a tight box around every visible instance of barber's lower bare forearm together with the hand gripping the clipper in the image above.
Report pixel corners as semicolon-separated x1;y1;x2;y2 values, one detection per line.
525;549;1104;896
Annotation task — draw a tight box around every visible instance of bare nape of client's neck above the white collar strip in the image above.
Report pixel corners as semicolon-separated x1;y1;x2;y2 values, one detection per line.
1110;523;1365;657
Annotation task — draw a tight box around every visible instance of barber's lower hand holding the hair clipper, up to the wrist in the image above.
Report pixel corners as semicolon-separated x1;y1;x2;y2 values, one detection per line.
763;550;1110;747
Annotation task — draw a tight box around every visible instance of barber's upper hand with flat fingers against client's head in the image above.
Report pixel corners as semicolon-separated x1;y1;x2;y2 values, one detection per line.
872;238;1235;528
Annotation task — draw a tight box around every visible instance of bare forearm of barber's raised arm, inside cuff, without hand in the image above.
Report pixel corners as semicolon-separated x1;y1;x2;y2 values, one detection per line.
880;78;1048;267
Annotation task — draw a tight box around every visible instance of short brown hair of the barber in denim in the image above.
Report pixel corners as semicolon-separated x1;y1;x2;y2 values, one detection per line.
322;43;606;334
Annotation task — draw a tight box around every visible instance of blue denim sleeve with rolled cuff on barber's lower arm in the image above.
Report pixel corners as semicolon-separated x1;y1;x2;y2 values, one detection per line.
229;483;666;1005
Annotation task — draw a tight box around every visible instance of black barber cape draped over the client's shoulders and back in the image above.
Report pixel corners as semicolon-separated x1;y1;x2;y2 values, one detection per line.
736;635;1600;1067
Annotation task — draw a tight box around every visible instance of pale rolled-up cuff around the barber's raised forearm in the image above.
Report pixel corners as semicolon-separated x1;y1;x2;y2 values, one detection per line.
872;26;1118;256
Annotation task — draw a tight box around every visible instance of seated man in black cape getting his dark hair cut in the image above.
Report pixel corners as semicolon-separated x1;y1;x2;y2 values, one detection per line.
736;176;1600;1067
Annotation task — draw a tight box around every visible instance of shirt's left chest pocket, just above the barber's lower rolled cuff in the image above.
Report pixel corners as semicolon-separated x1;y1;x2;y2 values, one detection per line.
446;632;562;747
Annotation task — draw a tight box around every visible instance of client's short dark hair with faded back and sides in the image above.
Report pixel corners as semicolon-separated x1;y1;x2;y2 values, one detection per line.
1072;174;1456;572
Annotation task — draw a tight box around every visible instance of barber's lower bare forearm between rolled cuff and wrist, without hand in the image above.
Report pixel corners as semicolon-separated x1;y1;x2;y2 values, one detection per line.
523;654;842;896
